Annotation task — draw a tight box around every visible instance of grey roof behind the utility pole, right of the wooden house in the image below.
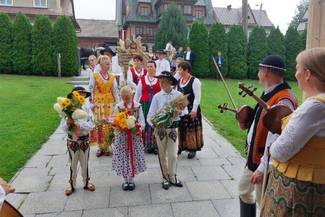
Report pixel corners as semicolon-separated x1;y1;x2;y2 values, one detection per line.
214;7;273;27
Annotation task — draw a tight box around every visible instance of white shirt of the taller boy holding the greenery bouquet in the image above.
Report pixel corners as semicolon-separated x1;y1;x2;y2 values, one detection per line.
147;89;188;126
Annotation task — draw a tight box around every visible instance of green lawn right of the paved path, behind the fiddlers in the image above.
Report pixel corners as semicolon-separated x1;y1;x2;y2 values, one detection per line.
201;79;301;156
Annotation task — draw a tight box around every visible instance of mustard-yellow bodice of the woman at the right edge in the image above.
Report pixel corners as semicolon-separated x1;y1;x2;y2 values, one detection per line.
272;97;325;184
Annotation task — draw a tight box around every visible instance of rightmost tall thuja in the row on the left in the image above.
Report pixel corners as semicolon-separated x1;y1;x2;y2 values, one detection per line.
53;16;79;76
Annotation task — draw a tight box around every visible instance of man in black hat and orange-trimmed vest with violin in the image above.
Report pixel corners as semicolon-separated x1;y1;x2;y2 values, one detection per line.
238;55;297;217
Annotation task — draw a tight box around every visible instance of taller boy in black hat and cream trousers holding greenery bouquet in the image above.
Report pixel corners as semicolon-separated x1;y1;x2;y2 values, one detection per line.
147;71;188;190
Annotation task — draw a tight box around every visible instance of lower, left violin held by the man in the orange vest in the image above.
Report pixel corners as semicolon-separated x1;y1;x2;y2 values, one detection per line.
218;103;253;130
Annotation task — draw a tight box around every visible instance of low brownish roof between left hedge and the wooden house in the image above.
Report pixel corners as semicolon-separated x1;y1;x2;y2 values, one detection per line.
77;19;118;38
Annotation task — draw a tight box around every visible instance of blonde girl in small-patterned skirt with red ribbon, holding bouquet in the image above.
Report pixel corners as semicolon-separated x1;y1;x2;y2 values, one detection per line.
112;86;146;191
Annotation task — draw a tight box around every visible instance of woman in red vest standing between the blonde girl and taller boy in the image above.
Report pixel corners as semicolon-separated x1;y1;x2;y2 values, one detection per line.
134;61;160;154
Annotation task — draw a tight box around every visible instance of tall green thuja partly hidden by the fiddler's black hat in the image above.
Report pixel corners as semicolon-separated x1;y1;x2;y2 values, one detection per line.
247;26;268;79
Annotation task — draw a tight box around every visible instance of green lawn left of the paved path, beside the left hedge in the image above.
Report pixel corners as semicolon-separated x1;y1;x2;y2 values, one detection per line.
0;75;71;180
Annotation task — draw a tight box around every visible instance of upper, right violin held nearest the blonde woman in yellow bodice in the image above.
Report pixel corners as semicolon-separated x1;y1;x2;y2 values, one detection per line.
238;82;292;134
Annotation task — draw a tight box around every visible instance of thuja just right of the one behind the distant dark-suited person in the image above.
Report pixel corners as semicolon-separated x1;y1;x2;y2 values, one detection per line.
228;25;247;79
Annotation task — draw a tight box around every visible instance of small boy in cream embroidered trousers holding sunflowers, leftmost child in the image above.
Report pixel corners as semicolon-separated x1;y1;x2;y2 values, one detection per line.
62;87;95;196
